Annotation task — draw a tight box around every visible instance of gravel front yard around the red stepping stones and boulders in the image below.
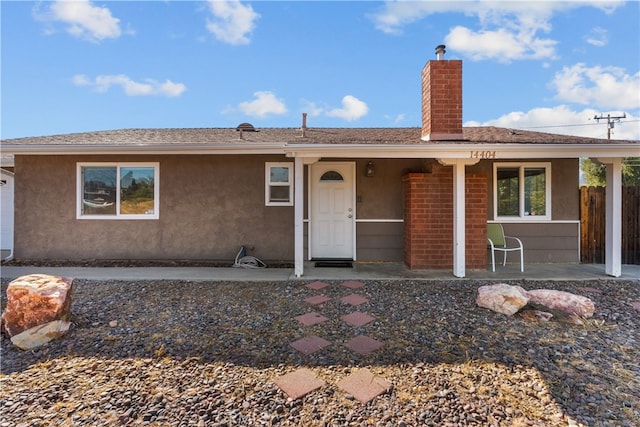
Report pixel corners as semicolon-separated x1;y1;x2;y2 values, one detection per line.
0;280;640;426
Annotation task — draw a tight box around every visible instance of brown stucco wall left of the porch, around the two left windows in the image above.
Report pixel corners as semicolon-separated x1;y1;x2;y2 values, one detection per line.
15;155;293;261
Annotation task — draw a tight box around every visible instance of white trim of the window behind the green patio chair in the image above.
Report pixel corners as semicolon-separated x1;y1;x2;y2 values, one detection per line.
493;162;551;222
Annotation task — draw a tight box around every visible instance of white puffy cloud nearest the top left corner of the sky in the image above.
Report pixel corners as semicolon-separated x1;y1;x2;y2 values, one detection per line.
34;0;122;42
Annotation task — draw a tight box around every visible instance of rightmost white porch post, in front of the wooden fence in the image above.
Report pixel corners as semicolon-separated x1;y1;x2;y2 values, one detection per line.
601;158;622;277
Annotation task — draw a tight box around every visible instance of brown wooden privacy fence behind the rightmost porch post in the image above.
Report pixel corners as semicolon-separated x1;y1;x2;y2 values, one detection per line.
580;186;640;264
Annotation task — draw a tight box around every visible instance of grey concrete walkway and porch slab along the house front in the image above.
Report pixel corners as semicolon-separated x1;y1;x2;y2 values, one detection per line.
0;262;640;282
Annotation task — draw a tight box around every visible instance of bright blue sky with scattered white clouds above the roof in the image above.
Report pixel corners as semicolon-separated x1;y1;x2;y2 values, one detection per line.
0;0;640;139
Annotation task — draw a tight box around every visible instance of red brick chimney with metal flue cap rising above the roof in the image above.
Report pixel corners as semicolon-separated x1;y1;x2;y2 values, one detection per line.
422;45;463;141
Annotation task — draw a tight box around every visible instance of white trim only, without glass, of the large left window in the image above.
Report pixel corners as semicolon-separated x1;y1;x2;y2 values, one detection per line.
76;162;160;220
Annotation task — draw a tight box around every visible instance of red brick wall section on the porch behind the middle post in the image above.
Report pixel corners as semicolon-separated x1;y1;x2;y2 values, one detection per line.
403;166;487;269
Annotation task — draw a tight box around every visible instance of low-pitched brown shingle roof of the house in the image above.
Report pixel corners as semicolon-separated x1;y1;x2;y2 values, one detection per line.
1;126;640;146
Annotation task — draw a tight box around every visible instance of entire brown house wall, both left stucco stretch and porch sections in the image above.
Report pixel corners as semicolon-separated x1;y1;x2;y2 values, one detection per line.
15;155;579;262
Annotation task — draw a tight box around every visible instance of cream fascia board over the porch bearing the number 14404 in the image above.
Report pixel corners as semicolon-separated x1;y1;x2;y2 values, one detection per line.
285;142;640;159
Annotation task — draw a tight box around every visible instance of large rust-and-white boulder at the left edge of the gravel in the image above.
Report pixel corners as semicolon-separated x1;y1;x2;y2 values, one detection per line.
2;274;72;350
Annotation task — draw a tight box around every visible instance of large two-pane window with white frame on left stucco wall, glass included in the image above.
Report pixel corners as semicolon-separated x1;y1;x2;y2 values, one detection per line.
77;163;160;219
